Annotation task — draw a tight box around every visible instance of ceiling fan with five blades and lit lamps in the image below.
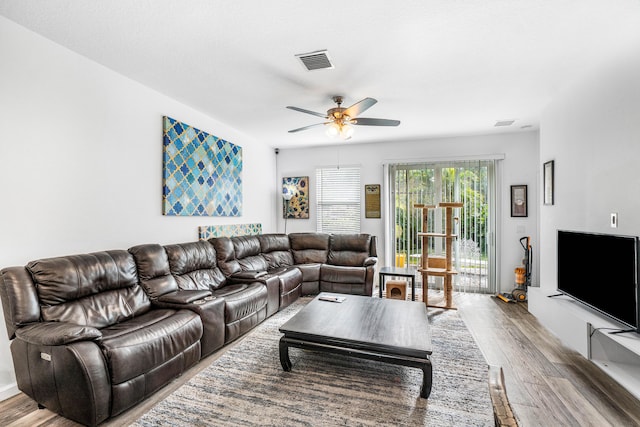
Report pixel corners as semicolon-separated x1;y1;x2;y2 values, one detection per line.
287;96;400;139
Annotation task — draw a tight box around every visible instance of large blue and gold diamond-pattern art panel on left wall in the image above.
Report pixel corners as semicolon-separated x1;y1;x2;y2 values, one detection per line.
162;116;242;216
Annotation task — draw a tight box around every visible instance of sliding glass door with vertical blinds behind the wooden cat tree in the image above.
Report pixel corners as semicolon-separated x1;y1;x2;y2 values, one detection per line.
389;160;495;293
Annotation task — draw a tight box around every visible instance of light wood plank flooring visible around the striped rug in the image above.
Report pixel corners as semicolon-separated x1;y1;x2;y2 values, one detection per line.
0;290;640;427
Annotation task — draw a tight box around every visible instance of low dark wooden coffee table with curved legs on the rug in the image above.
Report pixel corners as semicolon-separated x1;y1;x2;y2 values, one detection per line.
280;293;432;399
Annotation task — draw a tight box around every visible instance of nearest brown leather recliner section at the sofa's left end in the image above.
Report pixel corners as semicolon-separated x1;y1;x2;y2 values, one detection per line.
0;250;202;425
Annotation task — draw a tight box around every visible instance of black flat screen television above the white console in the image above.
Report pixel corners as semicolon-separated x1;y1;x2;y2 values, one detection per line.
557;230;640;332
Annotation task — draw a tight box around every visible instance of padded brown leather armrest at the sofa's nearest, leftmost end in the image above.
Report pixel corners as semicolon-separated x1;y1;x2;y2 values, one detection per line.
16;322;102;346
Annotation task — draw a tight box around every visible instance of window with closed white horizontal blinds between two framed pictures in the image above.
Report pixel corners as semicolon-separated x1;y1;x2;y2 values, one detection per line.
316;166;360;234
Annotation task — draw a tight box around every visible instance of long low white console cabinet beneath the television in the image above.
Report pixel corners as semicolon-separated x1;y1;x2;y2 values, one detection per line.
529;288;640;399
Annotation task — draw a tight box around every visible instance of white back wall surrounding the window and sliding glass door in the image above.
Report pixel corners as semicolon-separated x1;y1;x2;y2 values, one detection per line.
278;132;539;291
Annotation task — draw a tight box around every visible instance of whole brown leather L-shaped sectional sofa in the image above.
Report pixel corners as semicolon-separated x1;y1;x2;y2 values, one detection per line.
0;233;377;425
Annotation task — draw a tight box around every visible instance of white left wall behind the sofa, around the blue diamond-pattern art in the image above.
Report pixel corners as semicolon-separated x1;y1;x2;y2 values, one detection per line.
0;17;276;399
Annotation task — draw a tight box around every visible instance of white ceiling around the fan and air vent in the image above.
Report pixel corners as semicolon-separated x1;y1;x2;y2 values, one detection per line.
0;0;640;148
